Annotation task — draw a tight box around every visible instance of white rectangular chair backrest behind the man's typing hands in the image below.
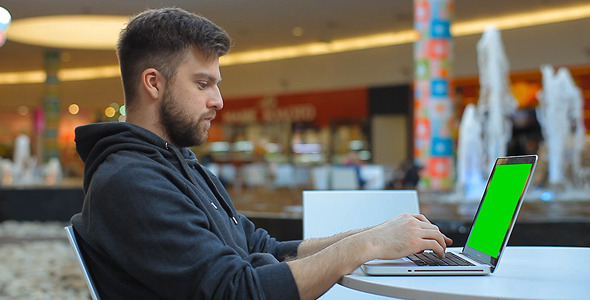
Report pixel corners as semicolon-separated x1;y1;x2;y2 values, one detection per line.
303;190;420;239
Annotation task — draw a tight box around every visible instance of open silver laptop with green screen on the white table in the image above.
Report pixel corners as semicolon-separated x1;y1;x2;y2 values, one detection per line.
362;155;537;275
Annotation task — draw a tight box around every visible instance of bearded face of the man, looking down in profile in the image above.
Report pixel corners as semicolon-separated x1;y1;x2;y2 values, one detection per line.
160;48;223;147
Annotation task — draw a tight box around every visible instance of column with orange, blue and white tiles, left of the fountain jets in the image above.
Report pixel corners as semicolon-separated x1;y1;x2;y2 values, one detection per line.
414;0;454;191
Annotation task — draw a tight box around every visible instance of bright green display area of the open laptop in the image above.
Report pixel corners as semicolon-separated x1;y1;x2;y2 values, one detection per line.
467;164;533;258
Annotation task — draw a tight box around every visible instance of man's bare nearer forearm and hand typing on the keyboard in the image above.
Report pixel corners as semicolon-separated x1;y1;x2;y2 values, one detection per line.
287;214;452;299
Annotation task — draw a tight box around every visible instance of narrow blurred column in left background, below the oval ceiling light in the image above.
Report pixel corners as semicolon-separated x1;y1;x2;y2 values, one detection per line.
39;50;61;162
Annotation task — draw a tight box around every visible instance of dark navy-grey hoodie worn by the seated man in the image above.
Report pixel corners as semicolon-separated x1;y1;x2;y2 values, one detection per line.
72;123;299;299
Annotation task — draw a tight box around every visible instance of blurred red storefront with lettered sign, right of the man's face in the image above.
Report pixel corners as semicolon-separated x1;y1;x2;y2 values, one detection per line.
200;88;370;165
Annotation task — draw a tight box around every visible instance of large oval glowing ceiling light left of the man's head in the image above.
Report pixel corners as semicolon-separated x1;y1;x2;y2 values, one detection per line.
8;15;129;50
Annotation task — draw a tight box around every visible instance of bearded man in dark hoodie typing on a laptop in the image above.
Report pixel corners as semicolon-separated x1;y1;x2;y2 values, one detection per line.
72;9;450;299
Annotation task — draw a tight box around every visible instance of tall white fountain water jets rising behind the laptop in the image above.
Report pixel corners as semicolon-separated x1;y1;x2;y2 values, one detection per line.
452;27;590;202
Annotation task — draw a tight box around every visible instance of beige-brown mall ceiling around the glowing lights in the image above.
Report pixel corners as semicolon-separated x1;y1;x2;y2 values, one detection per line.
0;0;587;72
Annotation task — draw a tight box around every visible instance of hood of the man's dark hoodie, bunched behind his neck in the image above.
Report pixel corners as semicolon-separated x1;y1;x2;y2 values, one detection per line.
75;122;198;192
